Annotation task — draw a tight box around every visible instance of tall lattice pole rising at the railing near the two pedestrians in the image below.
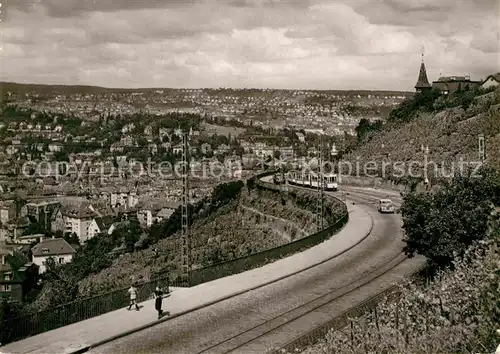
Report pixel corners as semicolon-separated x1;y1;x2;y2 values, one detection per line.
181;132;191;286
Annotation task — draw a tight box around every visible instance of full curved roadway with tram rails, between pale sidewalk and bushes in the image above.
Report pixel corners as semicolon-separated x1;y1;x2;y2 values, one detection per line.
87;183;414;354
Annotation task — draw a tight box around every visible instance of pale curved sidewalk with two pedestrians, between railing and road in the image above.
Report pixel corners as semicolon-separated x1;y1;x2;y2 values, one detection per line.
0;203;373;354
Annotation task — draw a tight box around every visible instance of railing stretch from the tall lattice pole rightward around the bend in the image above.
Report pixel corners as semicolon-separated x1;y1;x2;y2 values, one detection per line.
189;171;349;286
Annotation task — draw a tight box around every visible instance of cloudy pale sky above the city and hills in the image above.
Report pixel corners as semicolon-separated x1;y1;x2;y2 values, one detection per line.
0;0;500;91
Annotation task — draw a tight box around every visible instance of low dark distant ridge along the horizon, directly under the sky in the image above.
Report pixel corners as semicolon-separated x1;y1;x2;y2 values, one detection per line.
0;82;413;96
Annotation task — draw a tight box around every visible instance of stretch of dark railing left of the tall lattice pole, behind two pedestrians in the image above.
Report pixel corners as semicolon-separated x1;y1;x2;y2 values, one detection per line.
0;277;170;344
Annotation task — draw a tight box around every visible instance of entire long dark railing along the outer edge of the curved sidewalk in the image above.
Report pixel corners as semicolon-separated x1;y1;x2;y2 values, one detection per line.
0;171;349;344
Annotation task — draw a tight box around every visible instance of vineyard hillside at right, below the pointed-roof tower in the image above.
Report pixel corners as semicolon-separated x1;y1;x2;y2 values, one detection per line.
344;90;500;175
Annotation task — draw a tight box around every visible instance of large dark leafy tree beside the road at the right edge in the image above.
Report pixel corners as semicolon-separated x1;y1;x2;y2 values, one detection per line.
401;168;500;270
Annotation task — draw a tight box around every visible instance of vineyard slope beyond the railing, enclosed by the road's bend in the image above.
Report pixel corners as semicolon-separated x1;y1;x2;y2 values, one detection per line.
79;188;342;296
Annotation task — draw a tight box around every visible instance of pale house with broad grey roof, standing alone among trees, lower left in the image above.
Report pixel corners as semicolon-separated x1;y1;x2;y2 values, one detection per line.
31;238;76;274
